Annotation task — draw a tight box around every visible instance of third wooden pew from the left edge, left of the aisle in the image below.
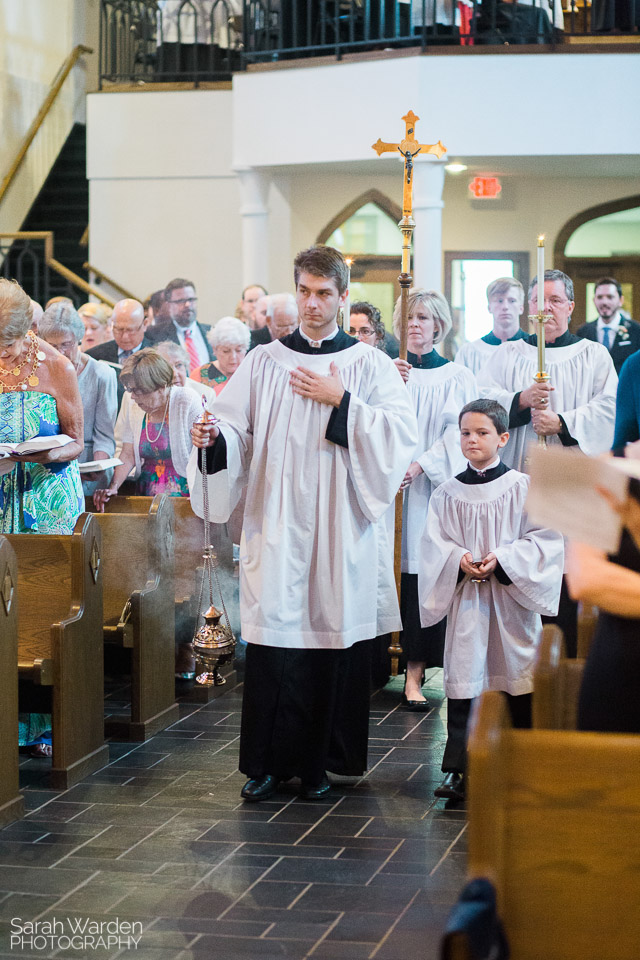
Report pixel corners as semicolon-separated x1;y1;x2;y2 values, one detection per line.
94;494;179;741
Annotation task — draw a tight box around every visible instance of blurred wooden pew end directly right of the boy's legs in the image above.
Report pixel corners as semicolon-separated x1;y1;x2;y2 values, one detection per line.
532;624;585;730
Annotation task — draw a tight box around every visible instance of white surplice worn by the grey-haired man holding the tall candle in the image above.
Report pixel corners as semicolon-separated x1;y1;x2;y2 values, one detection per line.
480;340;618;470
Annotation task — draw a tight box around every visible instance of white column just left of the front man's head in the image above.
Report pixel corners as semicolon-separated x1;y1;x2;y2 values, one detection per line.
236;167;269;290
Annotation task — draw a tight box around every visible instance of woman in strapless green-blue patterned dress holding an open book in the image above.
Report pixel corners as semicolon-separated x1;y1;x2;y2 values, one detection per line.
0;279;84;756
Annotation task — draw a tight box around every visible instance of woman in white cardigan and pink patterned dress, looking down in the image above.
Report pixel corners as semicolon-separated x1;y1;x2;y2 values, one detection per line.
93;347;202;510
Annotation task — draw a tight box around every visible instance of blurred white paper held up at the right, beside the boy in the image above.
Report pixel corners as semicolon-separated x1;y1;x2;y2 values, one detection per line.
526;444;640;553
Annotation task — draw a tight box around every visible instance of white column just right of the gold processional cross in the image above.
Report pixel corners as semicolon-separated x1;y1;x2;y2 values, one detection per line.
413;156;448;290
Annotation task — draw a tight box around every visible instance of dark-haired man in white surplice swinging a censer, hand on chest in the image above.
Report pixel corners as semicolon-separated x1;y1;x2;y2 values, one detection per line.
189;247;417;801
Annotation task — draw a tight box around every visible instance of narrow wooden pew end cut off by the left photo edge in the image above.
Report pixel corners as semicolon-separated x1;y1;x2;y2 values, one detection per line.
0;537;24;826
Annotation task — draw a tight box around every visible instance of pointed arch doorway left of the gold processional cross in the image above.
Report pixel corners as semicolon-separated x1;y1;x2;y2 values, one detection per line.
318;190;402;332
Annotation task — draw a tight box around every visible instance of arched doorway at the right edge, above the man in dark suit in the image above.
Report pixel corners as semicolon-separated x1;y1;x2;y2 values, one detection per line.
554;194;640;329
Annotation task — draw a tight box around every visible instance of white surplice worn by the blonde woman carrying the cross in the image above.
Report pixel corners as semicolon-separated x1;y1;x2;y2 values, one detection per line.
402;363;478;573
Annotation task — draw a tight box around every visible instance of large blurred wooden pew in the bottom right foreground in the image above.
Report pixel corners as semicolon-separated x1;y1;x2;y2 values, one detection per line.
468;692;640;960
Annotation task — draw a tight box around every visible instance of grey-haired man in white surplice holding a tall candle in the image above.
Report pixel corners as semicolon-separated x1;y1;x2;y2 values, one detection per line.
480;270;618;657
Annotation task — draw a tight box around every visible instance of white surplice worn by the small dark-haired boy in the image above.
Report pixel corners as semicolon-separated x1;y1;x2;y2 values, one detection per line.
418;470;564;699
